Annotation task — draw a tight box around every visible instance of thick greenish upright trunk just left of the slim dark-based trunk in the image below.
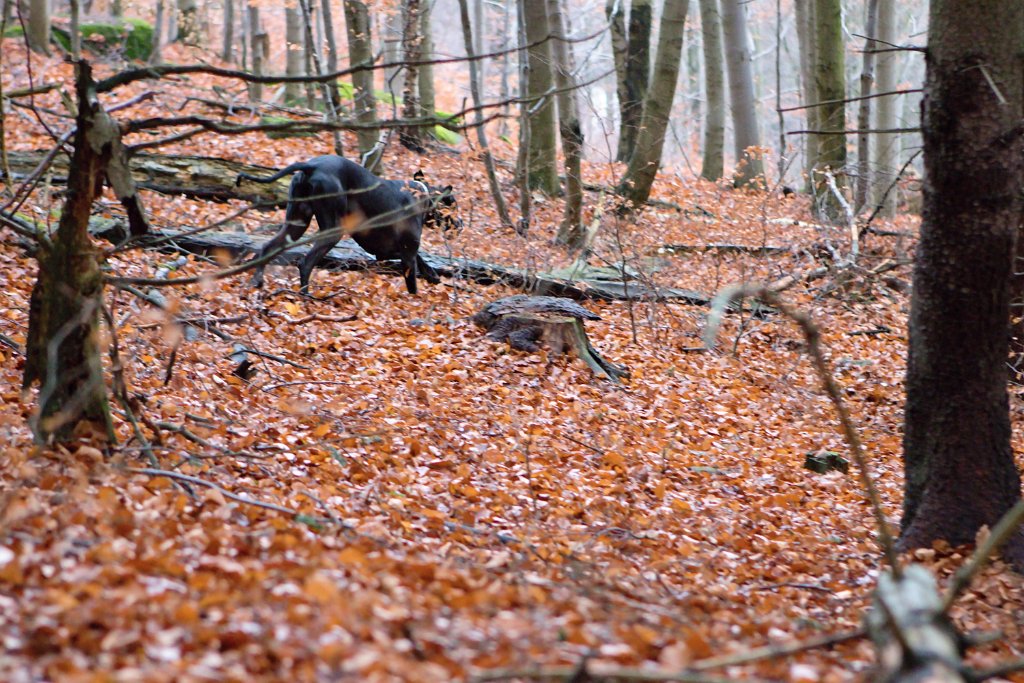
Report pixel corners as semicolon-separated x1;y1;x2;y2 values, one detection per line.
520;0;559;195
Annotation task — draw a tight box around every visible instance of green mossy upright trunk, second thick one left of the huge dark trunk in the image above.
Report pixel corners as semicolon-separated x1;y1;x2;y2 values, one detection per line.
812;0;847;222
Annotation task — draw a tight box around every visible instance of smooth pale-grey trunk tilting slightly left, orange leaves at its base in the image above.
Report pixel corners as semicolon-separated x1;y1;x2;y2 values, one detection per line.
722;0;764;187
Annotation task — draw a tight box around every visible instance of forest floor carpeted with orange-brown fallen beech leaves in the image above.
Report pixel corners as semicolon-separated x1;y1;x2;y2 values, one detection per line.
0;41;1024;682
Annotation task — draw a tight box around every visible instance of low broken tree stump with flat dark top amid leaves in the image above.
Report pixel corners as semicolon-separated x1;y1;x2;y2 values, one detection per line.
472;294;630;382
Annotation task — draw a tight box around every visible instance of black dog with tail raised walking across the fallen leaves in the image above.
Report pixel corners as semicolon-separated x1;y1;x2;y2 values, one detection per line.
237;155;461;294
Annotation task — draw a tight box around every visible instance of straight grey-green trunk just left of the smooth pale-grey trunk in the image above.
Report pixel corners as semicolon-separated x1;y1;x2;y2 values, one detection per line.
700;0;725;180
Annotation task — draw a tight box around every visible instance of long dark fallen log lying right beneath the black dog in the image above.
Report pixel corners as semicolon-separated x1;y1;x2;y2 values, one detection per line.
90;219;711;306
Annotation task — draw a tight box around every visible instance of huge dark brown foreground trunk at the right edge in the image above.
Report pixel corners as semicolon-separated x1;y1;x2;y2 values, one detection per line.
901;0;1024;569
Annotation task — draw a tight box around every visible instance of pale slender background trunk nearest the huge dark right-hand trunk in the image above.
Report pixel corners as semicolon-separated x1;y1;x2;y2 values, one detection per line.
871;0;901;218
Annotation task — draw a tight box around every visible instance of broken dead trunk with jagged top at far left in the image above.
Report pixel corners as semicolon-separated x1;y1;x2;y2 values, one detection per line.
23;60;113;441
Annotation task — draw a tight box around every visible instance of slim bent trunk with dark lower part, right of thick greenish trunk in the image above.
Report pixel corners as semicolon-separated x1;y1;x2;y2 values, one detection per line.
548;0;586;249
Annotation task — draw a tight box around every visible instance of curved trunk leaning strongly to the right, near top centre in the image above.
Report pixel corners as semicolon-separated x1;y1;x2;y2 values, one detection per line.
617;0;689;207
